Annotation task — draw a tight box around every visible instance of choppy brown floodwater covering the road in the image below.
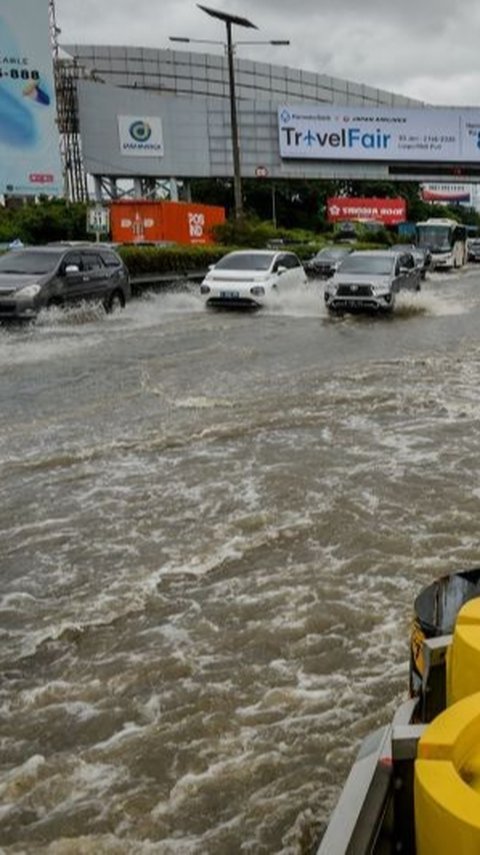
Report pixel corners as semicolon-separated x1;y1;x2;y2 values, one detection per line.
0;268;480;855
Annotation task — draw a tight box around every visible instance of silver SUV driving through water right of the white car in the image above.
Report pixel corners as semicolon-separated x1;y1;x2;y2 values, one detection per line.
324;250;421;313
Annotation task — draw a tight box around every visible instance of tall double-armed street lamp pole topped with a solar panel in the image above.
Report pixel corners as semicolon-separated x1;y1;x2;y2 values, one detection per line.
170;3;290;220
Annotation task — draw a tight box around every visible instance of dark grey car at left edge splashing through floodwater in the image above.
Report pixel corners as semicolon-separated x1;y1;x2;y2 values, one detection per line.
0;244;131;321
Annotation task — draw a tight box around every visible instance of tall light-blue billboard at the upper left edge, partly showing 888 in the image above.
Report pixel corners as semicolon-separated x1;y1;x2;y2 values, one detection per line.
0;0;62;196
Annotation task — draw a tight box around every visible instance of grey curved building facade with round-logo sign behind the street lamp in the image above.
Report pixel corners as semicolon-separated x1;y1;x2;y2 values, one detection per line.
59;45;423;198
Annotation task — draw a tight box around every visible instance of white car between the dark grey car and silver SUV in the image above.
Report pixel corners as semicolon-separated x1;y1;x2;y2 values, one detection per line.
200;249;307;308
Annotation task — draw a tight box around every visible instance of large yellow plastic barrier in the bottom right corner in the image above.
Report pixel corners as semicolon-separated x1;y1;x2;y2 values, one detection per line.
414;692;480;855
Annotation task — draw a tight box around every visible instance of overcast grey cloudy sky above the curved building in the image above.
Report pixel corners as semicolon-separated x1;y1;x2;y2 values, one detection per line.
56;0;480;106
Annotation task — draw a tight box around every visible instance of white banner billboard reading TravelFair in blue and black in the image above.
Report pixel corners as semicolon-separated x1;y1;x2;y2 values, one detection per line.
278;104;480;162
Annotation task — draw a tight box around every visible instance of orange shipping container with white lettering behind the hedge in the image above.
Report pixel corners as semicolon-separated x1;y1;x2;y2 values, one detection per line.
110;199;225;245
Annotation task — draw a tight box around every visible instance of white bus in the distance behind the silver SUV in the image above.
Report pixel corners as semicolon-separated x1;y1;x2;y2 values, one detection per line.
416;217;467;270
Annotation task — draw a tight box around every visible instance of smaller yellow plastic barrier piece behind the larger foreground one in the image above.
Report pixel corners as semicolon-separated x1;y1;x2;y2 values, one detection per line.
447;597;480;706
